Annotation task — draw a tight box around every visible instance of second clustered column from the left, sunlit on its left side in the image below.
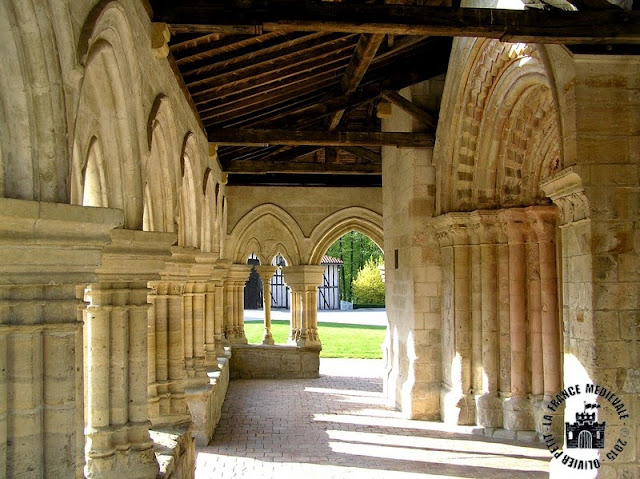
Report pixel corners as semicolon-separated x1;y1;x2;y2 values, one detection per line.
85;230;175;478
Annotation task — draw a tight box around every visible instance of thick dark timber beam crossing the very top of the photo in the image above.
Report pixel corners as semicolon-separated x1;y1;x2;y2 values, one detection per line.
154;0;640;44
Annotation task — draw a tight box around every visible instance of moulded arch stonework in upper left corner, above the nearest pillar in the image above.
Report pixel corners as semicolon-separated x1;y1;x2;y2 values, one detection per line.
0;0;69;203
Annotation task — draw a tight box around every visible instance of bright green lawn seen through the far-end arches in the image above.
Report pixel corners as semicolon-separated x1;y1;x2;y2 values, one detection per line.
244;320;387;359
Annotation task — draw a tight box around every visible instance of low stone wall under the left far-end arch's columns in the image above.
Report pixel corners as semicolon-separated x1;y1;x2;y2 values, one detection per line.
231;344;320;379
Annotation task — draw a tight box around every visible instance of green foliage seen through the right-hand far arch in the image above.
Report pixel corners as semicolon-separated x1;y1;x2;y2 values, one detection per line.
327;231;383;302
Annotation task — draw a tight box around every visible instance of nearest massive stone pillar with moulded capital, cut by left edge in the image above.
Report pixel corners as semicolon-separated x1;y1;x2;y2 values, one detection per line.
0;198;123;478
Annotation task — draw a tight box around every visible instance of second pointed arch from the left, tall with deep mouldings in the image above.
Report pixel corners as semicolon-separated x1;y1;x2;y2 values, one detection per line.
71;2;147;229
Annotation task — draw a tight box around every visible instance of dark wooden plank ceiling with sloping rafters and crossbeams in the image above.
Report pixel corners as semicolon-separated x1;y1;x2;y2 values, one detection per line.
151;0;637;186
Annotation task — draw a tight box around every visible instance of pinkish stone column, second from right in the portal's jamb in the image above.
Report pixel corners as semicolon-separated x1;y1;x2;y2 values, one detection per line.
503;209;533;431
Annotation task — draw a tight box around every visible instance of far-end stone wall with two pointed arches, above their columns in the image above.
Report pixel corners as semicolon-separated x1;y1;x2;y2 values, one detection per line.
226;186;383;265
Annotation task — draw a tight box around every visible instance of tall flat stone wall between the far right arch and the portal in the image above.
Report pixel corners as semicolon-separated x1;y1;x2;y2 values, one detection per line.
382;82;443;419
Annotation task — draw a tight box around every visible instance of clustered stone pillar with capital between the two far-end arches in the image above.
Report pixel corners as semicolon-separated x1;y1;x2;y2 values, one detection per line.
283;265;325;349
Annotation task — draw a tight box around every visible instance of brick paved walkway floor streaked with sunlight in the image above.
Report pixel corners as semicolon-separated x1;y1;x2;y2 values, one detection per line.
196;359;549;479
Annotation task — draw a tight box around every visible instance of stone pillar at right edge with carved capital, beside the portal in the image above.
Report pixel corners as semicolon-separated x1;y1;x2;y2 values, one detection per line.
541;55;640;477
